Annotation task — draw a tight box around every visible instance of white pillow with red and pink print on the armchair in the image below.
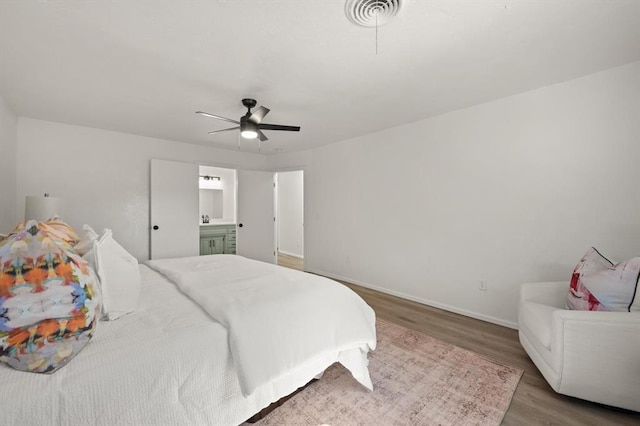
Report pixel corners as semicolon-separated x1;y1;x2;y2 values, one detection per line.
567;247;640;312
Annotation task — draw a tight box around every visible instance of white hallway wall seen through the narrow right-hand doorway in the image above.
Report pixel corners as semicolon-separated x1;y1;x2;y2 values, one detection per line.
277;170;304;257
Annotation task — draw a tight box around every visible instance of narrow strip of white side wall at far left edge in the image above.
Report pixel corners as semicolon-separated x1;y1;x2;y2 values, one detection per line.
0;97;19;233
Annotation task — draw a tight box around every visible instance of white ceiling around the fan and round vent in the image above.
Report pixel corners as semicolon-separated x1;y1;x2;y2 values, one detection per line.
0;0;640;154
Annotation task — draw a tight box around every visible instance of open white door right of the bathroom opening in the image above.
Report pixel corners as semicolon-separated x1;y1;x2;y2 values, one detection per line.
236;170;276;263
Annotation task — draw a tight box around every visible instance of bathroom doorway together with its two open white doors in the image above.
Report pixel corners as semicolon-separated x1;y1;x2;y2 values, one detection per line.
149;159;286;263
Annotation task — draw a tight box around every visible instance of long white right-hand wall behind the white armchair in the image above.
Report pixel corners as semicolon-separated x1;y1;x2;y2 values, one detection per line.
269;62;640;327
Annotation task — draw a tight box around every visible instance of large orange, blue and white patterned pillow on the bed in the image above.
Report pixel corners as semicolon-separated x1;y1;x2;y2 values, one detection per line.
0;220;101;373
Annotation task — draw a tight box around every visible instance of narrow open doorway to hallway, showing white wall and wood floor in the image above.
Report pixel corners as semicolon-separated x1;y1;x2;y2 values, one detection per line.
275;170;304;271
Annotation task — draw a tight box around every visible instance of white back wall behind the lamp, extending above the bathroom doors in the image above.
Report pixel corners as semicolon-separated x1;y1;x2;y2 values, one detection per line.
17;118;266;260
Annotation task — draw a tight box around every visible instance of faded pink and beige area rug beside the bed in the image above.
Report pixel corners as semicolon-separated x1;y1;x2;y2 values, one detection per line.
256;319;523;426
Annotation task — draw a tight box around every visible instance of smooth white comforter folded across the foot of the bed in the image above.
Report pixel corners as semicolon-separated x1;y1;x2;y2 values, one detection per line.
147;255;376;395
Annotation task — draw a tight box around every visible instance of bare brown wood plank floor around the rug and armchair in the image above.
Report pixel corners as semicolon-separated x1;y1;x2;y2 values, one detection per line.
278;256;640;426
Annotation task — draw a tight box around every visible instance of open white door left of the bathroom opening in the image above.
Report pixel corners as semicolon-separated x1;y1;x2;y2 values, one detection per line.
149;160;200;259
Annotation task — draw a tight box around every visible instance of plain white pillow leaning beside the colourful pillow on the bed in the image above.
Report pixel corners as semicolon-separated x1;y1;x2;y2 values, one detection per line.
83;229;141;321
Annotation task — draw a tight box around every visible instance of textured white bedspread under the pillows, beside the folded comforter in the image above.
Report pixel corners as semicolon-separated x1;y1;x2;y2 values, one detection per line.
0;265;298;426
